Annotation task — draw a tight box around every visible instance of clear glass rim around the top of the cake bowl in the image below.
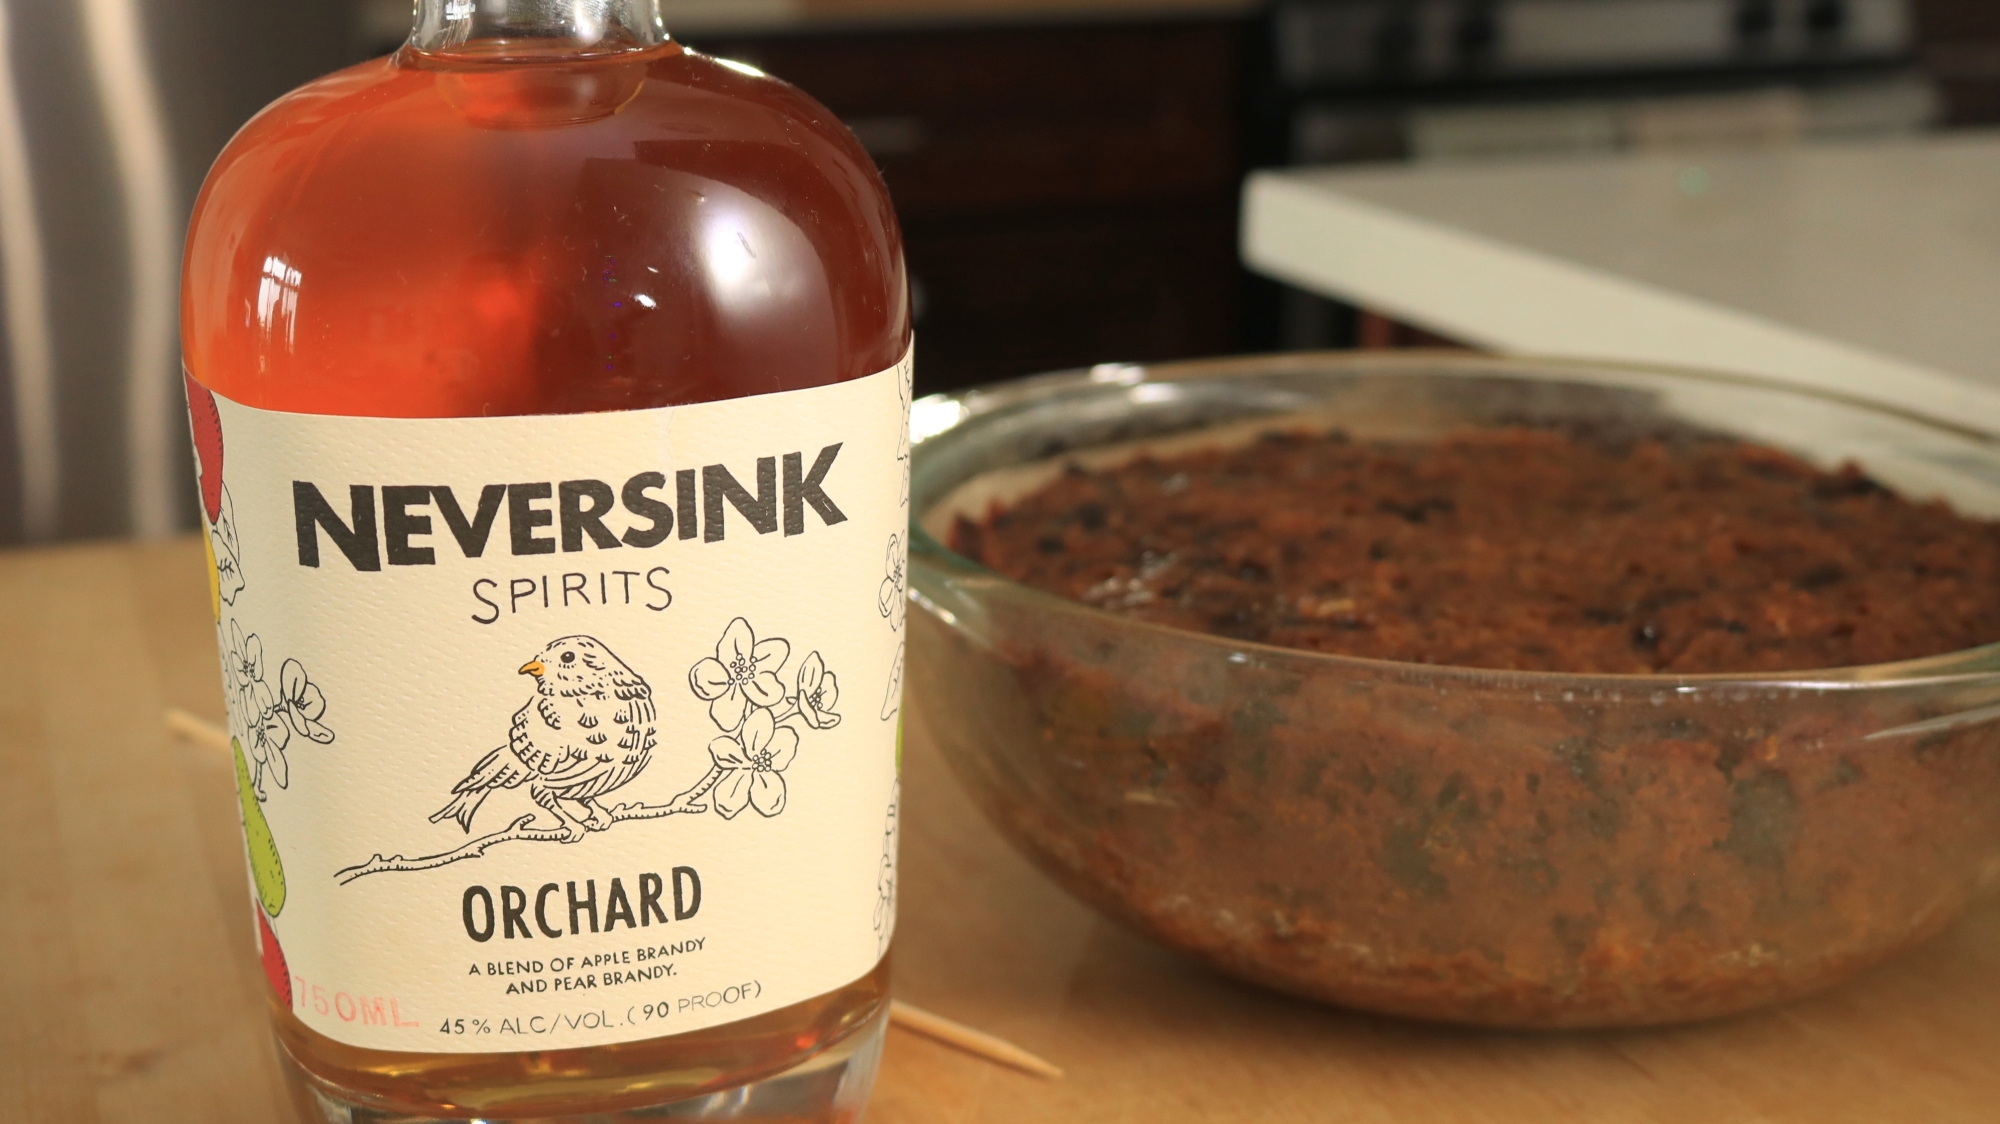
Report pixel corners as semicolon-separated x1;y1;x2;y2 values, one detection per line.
910;348;2000;696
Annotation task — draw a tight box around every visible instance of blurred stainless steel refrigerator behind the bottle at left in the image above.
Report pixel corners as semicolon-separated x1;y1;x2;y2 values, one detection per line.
0;0;352;542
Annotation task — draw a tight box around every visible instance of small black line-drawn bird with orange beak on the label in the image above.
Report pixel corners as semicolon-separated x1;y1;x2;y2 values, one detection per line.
430;636;656;842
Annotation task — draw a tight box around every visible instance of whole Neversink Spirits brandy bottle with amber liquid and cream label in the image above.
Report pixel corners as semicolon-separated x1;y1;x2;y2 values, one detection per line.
182;0;912;1122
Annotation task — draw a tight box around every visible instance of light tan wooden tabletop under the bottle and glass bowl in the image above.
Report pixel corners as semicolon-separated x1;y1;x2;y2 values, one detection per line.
0;542;2000;1124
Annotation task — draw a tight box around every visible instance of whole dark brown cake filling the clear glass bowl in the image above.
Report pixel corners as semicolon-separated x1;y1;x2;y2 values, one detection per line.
910;420;2000;1028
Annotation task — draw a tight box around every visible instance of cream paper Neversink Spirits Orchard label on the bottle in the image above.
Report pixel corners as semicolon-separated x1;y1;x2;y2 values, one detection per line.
190;352;910;1052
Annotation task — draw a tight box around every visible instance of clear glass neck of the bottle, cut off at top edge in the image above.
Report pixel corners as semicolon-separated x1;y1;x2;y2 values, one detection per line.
410;0;668;56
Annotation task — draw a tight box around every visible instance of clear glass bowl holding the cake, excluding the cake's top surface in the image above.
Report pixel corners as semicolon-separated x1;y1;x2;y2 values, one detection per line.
908;354;2000;1028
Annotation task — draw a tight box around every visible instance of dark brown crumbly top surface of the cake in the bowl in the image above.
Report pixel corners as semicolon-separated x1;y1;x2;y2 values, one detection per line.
952;428;2000;674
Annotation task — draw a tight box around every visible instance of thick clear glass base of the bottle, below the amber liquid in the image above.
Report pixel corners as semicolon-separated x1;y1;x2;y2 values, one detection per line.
278;1006;888;1124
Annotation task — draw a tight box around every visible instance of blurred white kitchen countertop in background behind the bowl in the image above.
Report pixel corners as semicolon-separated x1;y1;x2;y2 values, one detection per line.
1242;132;2000;432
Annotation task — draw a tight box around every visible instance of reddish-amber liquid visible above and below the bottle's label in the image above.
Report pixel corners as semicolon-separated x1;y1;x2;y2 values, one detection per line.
182;0;910;1118
